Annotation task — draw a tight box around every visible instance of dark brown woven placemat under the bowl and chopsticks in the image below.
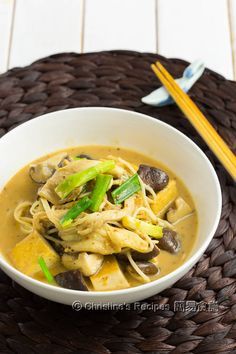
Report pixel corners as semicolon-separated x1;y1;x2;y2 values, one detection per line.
0;51;236;354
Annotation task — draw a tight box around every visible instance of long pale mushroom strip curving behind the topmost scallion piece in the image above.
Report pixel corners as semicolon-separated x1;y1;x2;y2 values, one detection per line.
38;159;99;204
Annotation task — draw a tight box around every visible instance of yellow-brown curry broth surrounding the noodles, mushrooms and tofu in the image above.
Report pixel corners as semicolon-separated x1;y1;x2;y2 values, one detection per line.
0;146;197;286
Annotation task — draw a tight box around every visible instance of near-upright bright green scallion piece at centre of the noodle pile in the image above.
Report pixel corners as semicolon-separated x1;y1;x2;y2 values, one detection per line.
90;175;112;211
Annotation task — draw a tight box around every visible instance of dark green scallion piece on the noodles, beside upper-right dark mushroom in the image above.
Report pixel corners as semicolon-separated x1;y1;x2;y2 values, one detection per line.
111;173;141;204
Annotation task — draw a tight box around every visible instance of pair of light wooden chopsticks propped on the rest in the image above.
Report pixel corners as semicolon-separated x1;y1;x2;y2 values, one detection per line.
151;62;236;181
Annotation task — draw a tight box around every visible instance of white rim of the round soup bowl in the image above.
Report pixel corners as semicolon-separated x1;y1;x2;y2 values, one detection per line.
0;107;222;299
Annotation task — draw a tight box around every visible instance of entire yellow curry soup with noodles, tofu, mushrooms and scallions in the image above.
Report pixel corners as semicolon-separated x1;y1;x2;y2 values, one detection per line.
0;146;197;291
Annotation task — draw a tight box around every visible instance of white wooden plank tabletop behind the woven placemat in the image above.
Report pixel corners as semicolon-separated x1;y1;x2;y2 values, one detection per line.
0;0;236;79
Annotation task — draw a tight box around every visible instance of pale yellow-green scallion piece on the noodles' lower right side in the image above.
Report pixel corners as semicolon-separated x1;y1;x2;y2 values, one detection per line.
122;216;163;239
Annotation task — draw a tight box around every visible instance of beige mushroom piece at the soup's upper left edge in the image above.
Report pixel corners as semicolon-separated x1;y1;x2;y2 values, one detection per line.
29;152;67;183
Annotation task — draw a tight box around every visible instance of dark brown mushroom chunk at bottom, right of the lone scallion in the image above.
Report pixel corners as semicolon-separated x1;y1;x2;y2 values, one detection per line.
55;270;88;291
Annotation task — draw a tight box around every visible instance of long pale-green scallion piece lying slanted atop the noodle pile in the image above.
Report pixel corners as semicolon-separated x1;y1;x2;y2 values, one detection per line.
55;160;115;199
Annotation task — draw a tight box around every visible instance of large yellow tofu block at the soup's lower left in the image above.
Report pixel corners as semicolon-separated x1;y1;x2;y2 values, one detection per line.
10;231;60;276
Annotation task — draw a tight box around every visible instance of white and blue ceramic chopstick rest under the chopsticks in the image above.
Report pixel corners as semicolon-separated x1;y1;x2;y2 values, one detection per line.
141;60;205;107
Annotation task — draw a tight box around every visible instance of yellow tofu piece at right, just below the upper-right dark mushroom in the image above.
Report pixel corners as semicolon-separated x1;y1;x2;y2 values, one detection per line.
152;180;178;217
